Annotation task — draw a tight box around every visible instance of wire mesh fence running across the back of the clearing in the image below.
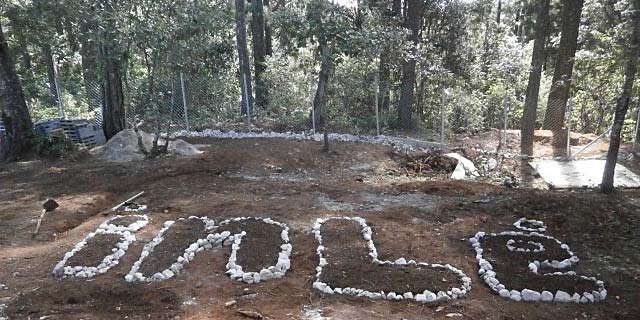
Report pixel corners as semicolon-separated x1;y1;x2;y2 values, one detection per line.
23;63;640;159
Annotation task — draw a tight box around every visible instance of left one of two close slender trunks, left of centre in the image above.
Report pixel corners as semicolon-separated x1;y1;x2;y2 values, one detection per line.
235;0;253;116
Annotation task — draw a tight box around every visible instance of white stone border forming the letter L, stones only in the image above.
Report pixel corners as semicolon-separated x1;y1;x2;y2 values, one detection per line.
313;217;471;303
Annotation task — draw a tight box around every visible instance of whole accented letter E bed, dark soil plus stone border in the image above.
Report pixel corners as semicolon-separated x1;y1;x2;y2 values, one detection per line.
469;218;607;303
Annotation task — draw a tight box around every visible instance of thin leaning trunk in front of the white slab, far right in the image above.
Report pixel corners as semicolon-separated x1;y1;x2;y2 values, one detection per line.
600;1;640;193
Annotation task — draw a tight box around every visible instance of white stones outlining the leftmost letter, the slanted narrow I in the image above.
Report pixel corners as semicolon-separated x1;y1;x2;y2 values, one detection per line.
53;215;149;278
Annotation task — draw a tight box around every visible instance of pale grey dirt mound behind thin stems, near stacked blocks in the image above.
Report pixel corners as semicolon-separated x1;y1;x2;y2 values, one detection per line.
90;129;202;162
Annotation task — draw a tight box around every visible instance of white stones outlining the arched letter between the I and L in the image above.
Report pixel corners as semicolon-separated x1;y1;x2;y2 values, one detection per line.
125;216;292;284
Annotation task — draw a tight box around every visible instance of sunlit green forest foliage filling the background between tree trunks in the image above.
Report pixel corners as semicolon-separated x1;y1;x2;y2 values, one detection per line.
5;0;638;139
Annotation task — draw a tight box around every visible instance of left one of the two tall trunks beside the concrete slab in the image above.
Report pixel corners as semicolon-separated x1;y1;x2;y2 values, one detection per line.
520;0;550;156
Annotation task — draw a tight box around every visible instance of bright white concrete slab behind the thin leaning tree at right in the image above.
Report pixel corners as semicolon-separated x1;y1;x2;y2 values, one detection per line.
529;159;640;189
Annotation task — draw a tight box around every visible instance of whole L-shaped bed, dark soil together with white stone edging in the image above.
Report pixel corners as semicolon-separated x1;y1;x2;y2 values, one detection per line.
313;217;471;303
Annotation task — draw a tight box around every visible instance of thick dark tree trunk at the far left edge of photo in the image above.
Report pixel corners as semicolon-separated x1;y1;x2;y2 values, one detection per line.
0;20;33;161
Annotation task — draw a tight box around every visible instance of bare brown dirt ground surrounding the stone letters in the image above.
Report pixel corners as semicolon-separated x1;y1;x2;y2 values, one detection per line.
0;139;640;320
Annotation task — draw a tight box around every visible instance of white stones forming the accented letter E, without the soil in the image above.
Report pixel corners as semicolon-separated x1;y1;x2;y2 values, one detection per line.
469;218;607;303
